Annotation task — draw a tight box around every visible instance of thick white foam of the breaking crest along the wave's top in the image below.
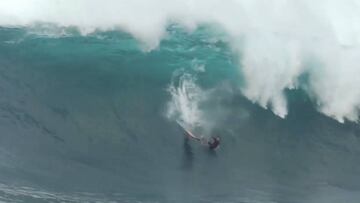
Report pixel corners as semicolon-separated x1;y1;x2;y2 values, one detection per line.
0;0;360;122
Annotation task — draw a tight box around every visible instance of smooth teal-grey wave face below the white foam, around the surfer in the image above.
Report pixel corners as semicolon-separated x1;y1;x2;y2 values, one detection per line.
0;26;360;203
